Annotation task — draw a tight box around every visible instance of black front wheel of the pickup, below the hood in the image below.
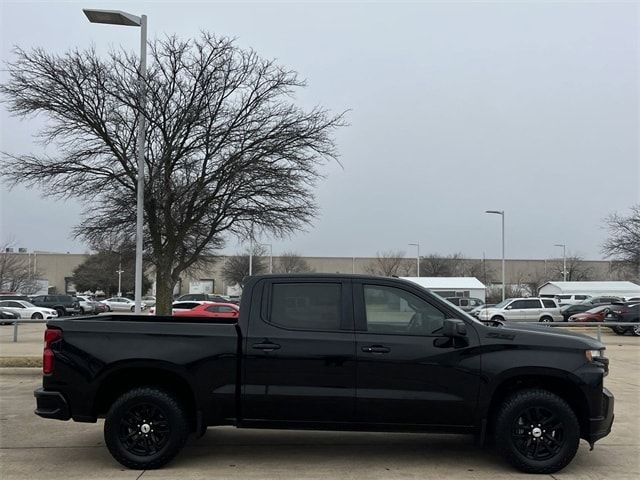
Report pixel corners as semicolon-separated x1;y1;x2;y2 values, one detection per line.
495;389;580;474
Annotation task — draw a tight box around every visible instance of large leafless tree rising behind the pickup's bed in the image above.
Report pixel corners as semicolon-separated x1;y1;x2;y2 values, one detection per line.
0;33;344;314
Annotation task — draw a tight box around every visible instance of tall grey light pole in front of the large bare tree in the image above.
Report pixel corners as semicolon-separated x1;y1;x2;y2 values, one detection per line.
82;8;147;314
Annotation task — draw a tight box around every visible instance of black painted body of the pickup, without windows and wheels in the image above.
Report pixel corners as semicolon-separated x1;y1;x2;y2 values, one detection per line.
35;274;613;442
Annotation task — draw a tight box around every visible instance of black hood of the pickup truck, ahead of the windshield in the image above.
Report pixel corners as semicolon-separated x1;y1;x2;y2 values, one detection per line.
487;322;604;350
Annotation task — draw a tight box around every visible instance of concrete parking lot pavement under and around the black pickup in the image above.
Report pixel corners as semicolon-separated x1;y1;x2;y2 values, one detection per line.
0;335;640;480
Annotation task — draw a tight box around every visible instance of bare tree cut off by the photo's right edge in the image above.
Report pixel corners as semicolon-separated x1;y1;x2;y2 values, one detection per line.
602;204;640;278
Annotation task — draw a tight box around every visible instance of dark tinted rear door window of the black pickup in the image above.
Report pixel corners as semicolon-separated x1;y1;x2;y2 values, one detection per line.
269;283;342;330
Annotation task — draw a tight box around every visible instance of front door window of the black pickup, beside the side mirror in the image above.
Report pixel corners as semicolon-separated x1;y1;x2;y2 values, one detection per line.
364;285;445;335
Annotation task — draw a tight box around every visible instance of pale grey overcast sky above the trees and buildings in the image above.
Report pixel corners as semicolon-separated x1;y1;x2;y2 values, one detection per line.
0;0;640;259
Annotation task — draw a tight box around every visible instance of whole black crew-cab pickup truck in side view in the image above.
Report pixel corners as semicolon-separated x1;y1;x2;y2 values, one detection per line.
35;274;614;473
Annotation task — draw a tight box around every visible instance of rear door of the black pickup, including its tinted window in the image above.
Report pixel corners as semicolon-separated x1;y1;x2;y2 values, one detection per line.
241;277;356;422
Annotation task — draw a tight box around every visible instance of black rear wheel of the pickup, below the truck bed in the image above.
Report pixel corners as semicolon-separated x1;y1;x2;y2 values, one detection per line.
104;387;189;470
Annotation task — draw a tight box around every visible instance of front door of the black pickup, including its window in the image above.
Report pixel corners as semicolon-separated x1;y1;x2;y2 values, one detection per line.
353;280;480;426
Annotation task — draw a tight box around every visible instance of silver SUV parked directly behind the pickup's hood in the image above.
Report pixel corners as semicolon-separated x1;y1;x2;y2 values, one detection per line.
478;297;563;322
